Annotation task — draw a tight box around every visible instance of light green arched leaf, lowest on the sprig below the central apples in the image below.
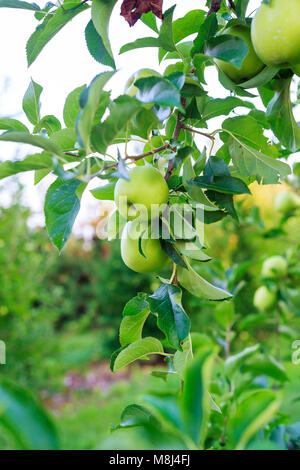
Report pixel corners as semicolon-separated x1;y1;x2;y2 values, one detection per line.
113;336;164;372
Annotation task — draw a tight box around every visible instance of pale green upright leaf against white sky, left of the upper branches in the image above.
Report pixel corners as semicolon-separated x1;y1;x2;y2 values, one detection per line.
77;72;114;149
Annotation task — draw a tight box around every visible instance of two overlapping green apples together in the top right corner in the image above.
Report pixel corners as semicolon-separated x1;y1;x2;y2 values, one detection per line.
215;0;300;83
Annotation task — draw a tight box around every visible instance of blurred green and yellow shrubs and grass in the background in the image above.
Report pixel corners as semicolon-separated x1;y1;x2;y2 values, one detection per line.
0;181;300;449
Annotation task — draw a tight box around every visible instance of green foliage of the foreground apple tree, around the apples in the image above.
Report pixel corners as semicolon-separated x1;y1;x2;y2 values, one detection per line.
0;0;300;449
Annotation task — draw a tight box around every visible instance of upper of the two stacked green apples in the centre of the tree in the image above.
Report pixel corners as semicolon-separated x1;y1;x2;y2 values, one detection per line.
114;166;169;220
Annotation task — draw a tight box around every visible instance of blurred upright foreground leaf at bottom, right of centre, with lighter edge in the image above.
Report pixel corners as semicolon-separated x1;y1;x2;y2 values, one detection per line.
181;348;216;447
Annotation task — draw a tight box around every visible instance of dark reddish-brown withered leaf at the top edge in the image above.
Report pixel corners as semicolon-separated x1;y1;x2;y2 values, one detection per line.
121;0;163;26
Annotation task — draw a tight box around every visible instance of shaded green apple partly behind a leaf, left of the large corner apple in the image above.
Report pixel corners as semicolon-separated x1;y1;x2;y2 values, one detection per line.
215;25;264;83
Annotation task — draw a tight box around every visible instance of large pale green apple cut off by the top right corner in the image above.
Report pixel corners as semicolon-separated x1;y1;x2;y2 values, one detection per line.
251;0;300;67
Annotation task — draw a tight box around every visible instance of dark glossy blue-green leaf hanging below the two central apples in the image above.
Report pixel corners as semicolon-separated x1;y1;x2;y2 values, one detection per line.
149;284;191;350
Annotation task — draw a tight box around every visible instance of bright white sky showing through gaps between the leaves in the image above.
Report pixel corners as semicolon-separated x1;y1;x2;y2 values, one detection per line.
0;0;298;234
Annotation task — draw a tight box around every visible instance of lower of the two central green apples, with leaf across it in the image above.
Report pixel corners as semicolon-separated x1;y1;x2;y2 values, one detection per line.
121;220;170;273
